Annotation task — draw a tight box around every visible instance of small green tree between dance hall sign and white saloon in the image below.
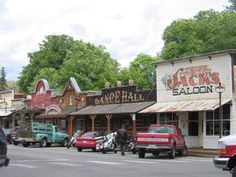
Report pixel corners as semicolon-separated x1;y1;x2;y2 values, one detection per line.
129;54;160;89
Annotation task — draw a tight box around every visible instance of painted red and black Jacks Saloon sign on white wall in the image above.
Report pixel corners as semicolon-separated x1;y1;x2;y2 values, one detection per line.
162;65;220;96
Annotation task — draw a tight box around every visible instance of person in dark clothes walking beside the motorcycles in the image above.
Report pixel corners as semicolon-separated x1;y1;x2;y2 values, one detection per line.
117;124;128;155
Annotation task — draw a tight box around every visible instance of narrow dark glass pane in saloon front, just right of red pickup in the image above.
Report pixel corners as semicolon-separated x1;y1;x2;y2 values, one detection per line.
188;112;198;136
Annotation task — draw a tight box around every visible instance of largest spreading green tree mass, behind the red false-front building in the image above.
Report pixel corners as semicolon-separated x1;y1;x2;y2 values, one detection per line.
17;35;119;93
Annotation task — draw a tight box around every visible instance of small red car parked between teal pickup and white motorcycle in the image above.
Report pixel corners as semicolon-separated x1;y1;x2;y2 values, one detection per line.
75;132;103;151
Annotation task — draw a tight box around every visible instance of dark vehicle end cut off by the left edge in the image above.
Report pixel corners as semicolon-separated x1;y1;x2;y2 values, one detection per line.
0;127;10;167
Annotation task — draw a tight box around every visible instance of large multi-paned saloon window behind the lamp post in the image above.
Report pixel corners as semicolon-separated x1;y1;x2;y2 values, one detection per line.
206;104;230;136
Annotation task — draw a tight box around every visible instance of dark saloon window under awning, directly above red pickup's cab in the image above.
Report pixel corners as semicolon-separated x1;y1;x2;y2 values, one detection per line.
160;112;179;127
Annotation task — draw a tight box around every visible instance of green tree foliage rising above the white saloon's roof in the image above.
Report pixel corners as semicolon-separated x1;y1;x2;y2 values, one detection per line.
161;10;236;60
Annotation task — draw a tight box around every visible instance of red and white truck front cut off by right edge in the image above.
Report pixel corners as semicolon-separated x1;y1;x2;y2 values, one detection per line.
213;135;236;177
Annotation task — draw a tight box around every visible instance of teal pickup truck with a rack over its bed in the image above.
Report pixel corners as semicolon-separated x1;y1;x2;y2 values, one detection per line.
14;122;69;147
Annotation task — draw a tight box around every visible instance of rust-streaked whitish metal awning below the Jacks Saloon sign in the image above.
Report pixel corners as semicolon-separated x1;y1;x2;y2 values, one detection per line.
139;99;231;113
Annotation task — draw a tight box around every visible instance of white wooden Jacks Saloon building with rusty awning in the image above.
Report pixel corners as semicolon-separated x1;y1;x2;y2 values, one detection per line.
141;50;236;149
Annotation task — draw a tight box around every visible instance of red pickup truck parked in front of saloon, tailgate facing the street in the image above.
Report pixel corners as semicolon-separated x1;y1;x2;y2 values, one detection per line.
136;124;187;159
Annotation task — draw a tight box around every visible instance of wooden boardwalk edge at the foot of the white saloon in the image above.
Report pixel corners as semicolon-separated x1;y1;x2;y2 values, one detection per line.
188;148;217;157
